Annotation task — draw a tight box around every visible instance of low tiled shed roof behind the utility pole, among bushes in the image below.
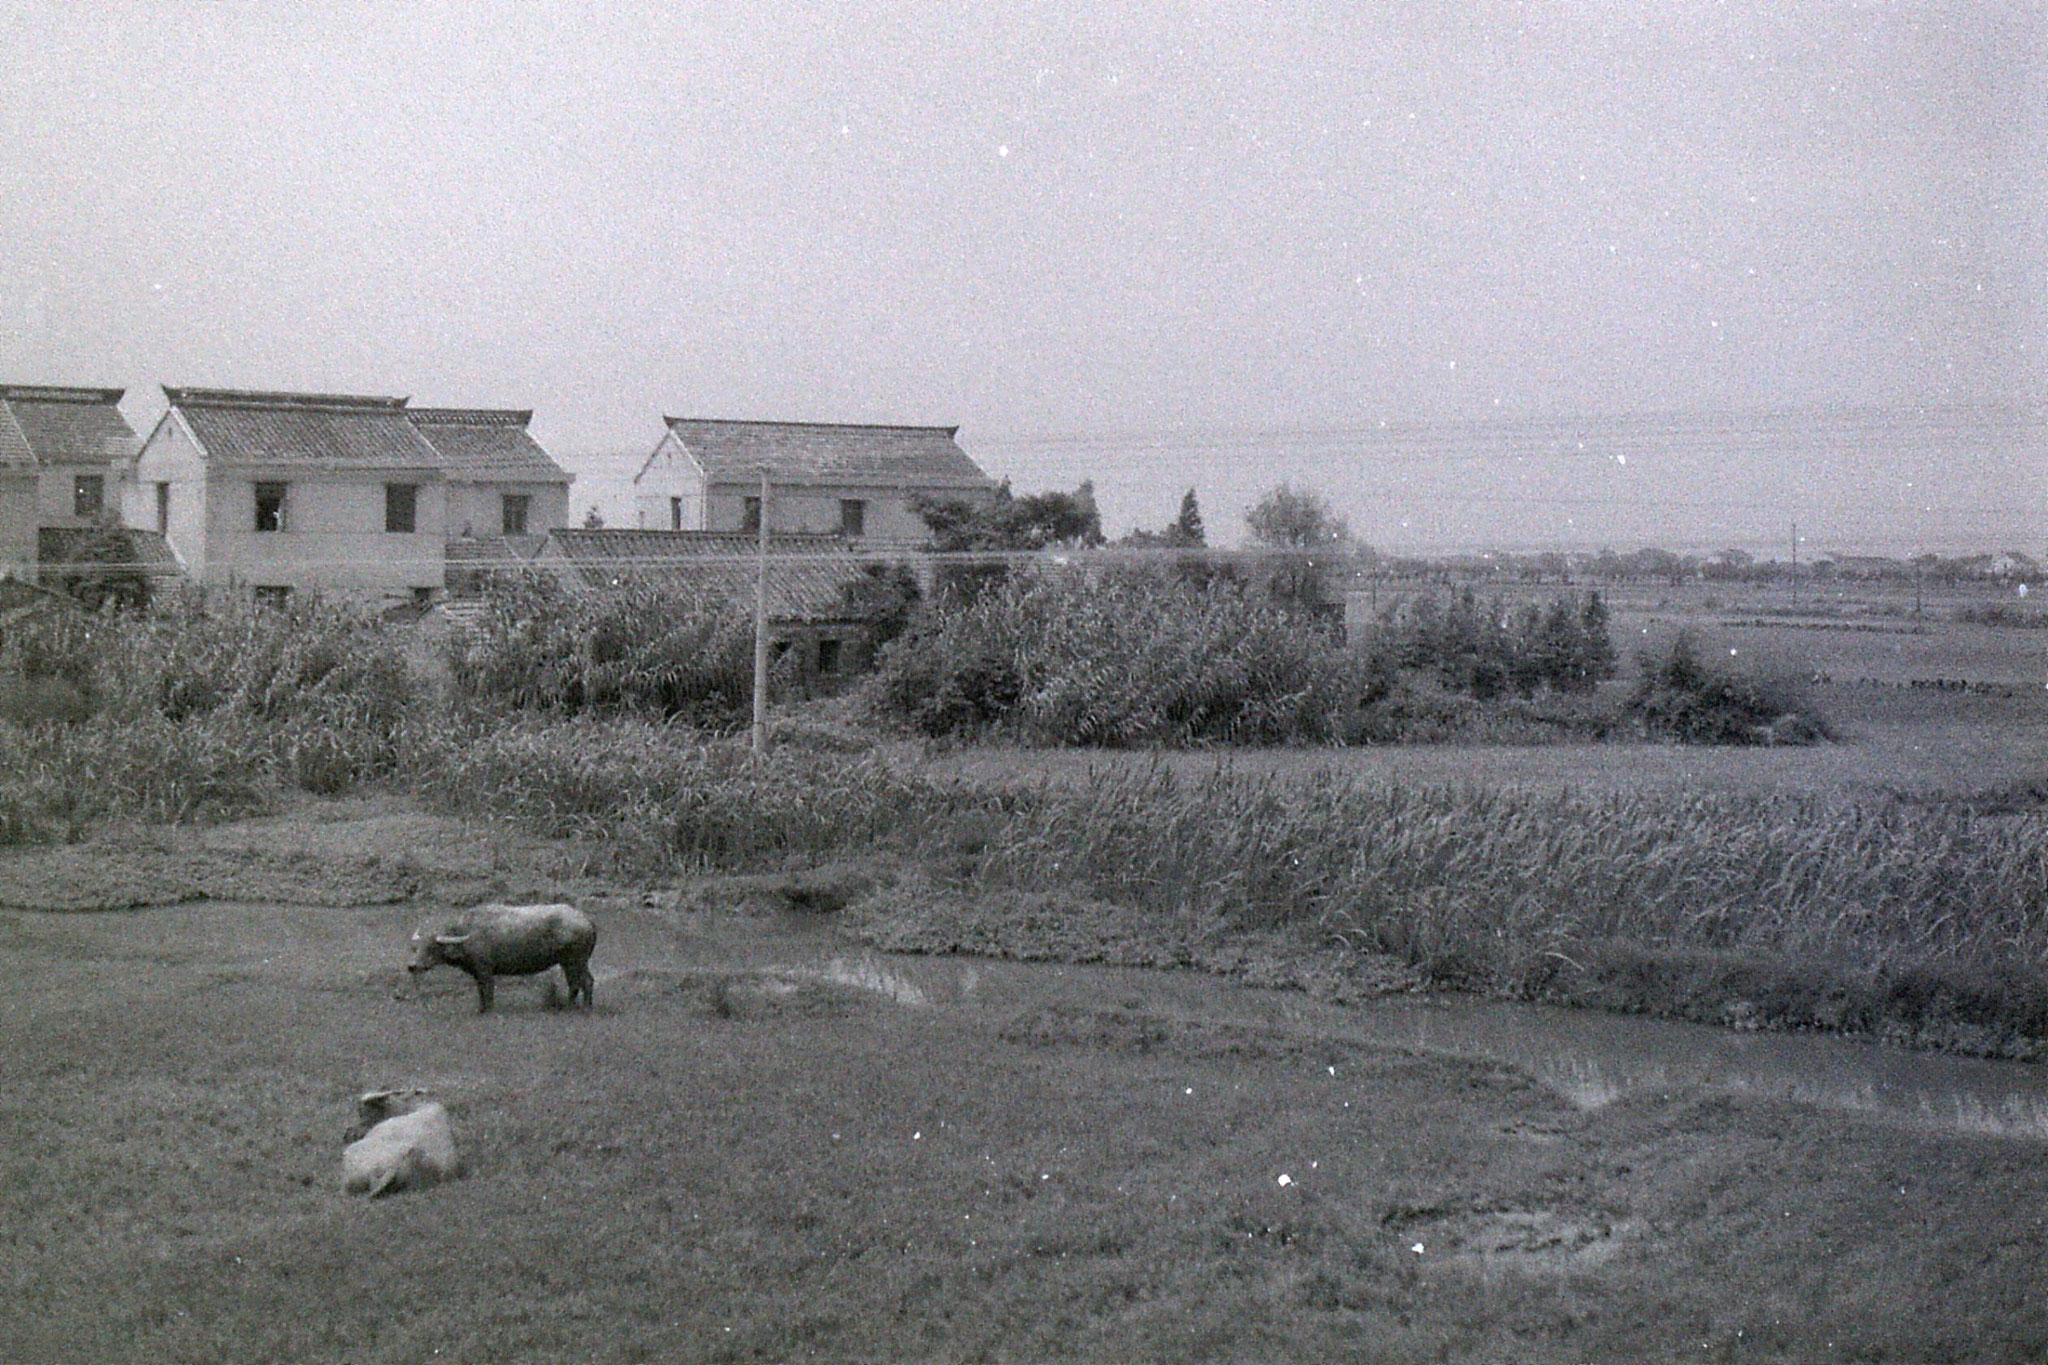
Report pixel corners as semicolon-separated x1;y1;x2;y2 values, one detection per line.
543;528;866;620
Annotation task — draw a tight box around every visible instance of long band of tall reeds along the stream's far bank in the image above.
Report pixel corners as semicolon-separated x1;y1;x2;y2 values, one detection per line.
399;718;2048;993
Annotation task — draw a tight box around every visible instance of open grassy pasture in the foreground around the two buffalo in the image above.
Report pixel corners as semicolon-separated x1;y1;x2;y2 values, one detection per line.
0;802;2048;1363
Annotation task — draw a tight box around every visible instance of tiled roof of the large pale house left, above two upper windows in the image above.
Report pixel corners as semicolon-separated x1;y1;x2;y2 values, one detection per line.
164;385;440;469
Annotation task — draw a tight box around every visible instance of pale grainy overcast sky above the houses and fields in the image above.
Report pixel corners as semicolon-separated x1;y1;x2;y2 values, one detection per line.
0;0;2048;553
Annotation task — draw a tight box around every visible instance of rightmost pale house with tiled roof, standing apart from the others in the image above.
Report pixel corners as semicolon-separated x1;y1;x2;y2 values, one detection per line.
633;417;995;544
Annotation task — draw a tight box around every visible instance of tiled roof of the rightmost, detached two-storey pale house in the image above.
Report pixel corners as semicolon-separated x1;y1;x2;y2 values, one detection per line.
641;417;989;489
